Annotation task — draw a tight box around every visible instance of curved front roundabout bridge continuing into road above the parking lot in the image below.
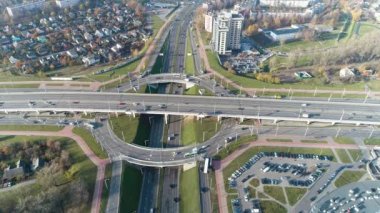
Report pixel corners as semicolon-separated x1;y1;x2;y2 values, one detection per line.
87;116;380;167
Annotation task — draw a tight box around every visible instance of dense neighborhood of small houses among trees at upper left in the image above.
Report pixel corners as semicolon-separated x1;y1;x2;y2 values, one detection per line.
0;0;152;74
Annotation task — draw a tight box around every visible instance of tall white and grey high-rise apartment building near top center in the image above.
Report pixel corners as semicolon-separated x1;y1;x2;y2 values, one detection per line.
211;11;244;55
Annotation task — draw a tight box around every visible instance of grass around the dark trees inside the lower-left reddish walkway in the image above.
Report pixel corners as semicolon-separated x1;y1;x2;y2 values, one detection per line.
0;136;97;212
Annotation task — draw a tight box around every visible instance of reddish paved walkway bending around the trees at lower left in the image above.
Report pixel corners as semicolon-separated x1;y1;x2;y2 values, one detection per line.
0;126;108;213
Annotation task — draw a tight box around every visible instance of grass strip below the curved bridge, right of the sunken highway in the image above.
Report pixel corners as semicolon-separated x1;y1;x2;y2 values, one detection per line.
179;166;201;213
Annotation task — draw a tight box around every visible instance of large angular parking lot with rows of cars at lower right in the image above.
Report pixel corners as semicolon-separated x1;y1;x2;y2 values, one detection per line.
228;152;366;212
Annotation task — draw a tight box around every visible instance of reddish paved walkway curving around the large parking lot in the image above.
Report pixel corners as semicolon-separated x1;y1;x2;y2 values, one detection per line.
215;135;373;213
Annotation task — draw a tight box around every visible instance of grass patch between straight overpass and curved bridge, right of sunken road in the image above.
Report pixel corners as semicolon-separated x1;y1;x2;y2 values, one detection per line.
181;117;220;146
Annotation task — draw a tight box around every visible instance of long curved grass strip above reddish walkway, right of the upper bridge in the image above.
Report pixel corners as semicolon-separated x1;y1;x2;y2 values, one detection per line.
206;51;380;90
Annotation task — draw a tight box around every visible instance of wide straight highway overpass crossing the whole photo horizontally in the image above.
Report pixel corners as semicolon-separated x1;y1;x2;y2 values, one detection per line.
0;92;380;125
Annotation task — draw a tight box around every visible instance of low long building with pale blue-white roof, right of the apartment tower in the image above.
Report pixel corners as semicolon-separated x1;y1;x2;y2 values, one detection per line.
269;25;304;41
